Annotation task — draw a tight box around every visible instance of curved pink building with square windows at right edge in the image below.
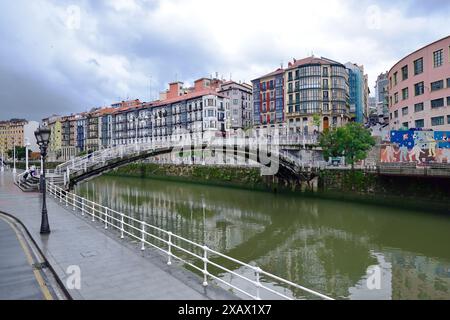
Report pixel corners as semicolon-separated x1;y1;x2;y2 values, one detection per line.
389;36;450;131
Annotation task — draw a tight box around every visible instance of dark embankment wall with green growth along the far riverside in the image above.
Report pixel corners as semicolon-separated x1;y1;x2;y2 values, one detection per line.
107;163;450;213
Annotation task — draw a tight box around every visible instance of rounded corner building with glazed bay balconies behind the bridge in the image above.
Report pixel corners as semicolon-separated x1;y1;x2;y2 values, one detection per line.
284;56;350;134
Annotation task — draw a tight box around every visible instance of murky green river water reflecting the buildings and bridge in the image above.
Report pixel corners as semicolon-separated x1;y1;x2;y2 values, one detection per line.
77;177;450;299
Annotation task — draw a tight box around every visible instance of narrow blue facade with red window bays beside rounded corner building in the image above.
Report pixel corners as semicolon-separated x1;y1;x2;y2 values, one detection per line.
252;68;285;135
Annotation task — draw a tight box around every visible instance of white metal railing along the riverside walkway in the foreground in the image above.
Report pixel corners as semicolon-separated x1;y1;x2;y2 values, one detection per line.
47;183;333;300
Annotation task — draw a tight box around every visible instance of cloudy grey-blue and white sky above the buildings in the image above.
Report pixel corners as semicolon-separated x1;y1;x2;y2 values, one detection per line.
0;0;450;120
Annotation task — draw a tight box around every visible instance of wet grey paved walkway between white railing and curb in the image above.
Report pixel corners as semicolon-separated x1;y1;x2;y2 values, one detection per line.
0;172;236;300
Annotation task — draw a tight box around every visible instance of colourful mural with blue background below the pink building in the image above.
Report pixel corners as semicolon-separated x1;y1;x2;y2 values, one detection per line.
380;130;450;165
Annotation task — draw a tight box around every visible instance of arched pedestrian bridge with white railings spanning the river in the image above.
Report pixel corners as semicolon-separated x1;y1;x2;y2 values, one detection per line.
55;140;324;190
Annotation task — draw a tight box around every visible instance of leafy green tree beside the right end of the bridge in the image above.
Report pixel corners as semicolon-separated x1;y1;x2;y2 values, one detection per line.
319;122;375;169
